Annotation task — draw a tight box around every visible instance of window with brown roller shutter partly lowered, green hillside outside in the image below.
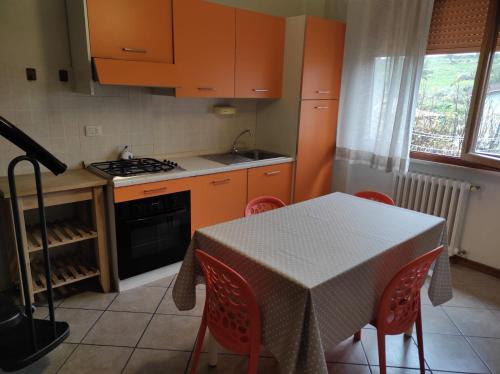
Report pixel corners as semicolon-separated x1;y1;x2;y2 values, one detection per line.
411;0;500;168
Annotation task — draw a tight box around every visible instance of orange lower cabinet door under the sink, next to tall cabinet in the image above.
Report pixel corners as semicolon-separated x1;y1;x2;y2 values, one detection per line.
248;163;292;204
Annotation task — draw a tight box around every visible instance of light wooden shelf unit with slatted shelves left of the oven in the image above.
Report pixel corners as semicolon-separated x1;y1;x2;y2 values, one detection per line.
0;169;110;300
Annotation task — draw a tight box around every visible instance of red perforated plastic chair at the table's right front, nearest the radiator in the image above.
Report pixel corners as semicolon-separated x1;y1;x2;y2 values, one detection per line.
354;246;443;374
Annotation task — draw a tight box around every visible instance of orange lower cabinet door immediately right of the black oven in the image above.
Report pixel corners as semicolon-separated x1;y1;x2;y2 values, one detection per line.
191;170;247;230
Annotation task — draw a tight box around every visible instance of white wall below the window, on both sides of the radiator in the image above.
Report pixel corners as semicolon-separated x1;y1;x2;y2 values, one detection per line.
334;160;500;269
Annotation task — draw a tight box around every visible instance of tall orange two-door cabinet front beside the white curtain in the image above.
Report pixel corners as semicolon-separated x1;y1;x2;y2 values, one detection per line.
294;17;345;202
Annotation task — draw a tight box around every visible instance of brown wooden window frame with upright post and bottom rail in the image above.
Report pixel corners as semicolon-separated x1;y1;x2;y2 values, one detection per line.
410;0;500;171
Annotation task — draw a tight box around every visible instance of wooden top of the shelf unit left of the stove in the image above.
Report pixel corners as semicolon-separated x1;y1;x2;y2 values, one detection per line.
0;169;108;199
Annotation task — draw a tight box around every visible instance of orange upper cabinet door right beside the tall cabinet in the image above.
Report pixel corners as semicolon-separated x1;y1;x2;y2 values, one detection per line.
235;9;285;98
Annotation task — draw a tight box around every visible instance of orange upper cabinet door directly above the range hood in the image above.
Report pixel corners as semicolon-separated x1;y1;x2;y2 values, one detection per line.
87;0;174;64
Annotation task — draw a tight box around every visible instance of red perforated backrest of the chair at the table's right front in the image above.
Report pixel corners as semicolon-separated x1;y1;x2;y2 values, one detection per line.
376;246;443;335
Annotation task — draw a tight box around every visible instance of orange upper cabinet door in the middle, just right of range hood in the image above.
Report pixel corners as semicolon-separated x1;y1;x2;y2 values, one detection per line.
174;0;235;98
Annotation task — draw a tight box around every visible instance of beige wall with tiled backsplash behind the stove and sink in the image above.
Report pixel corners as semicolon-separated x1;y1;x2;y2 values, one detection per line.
0;0;256;176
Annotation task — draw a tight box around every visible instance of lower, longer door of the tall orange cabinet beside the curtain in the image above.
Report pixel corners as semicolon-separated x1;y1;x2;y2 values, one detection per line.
294;100;338;203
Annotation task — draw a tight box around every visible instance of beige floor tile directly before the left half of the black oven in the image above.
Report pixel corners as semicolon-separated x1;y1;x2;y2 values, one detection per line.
108;287;166;313
